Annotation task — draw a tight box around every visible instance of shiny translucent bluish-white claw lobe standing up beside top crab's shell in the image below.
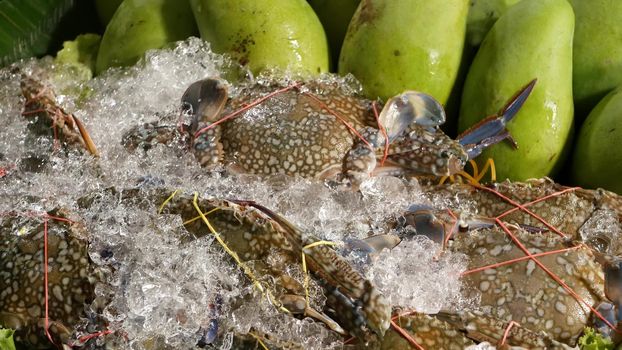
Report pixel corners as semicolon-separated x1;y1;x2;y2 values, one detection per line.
378;91;445;142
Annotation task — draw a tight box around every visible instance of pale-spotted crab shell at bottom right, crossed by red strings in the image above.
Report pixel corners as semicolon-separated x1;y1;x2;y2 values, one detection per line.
451;228;605;346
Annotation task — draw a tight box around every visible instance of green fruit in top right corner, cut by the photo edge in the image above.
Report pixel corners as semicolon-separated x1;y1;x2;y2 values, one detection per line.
570;0;622;121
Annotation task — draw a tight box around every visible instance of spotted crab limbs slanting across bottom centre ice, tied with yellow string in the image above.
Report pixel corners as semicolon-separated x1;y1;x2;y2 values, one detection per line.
152;189;391;337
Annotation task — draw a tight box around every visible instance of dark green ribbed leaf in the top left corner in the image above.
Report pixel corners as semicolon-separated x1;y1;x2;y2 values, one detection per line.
0;0;75;67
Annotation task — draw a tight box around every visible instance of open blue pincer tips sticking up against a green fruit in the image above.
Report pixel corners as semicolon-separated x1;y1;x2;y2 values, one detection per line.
458;79;537;159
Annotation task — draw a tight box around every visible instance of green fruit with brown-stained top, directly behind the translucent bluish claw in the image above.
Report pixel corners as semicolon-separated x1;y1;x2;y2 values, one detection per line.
339;0;469;104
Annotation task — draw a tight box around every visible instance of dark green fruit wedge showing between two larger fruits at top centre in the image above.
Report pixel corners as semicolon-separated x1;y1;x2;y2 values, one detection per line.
308;0;361;70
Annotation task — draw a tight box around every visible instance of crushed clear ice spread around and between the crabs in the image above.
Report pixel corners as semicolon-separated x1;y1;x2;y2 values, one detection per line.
0;39;466;349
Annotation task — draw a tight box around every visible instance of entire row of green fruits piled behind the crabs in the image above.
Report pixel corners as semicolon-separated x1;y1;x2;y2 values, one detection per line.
1;0;622;194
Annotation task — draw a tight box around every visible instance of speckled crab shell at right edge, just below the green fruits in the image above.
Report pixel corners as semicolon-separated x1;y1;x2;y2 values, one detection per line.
426;178;622;250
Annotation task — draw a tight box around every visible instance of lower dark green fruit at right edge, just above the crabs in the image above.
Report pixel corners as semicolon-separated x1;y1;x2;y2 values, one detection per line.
572;88;622;194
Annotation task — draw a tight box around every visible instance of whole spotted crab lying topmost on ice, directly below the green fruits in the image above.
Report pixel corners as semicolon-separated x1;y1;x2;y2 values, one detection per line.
123;78;535;184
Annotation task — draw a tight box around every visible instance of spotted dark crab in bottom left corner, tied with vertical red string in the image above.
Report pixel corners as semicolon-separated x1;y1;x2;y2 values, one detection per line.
0;209;97;349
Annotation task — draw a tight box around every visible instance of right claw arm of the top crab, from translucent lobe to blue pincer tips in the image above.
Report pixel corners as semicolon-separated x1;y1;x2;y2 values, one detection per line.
366;79;536;176
